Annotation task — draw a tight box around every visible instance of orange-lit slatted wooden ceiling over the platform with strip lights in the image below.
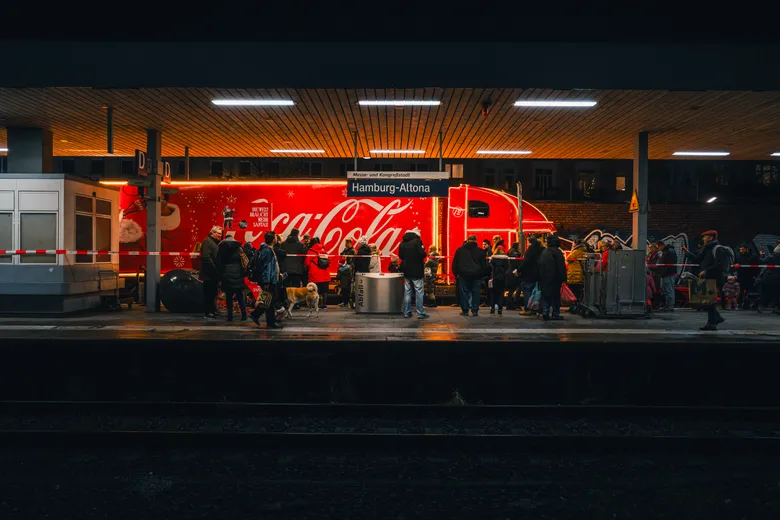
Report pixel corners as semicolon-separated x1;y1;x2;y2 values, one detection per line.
0;88;780;160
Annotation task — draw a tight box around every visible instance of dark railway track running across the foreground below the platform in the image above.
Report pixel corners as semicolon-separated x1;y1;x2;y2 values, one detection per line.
0;401;780;453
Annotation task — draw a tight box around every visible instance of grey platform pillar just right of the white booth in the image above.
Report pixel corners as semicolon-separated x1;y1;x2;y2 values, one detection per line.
146;128;162;312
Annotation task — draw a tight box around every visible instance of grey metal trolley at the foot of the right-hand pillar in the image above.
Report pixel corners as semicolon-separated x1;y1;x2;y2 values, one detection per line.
580;250;647;318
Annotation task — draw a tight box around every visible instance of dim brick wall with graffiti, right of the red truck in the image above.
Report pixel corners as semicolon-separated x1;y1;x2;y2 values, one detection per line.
533;202;780;245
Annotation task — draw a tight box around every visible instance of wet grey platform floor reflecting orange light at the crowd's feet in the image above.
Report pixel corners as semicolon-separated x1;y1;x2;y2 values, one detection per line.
0;306;780;344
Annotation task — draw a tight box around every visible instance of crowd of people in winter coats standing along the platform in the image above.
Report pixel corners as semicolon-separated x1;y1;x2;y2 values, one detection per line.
200;222;780;330
